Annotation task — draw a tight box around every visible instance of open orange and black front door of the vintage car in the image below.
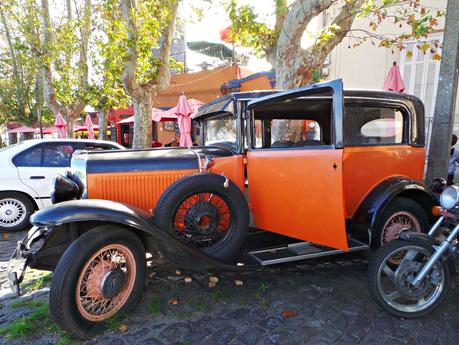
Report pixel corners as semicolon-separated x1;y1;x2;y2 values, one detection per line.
247;80;348;250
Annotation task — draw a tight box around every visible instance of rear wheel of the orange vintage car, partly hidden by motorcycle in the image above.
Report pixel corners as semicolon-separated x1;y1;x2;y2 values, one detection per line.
372;197;429;249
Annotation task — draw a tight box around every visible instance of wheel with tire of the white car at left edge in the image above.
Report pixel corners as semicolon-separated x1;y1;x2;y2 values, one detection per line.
0;192;34;232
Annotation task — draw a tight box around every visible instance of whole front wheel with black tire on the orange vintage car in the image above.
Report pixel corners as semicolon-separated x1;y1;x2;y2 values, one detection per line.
49;225;146;339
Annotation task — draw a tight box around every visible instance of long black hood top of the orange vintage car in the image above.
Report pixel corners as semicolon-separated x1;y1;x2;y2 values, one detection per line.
72;147;233;174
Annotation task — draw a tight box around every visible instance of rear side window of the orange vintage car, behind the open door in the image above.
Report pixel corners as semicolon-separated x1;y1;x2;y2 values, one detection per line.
344;105;407;146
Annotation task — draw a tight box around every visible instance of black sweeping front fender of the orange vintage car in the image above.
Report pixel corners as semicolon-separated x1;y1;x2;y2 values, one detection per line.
30;199;249;270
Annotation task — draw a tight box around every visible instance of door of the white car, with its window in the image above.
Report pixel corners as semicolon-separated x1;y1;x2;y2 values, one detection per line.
13;142;75;205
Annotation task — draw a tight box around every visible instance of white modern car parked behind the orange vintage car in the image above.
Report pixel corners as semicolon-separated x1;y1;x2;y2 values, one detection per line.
0;139;124;232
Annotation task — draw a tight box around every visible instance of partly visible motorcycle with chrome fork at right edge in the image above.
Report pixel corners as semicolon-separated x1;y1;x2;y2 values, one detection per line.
368;181;459;318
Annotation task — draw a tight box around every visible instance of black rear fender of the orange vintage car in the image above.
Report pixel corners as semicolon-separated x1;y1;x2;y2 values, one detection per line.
350;176;438;244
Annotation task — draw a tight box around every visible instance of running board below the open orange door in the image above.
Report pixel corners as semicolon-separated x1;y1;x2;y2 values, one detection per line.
249;239;369;266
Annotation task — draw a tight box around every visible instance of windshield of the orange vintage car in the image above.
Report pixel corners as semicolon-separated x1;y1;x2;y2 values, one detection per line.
204;114;237;145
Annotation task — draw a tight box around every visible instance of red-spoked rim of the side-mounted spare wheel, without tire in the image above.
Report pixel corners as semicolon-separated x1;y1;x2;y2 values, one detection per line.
173;193;231;248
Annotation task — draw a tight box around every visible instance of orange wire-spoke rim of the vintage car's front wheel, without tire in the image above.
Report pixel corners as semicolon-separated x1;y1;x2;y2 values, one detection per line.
76;244;136;321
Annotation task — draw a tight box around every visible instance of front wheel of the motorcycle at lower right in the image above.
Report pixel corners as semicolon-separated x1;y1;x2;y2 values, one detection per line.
368;239;451;318
